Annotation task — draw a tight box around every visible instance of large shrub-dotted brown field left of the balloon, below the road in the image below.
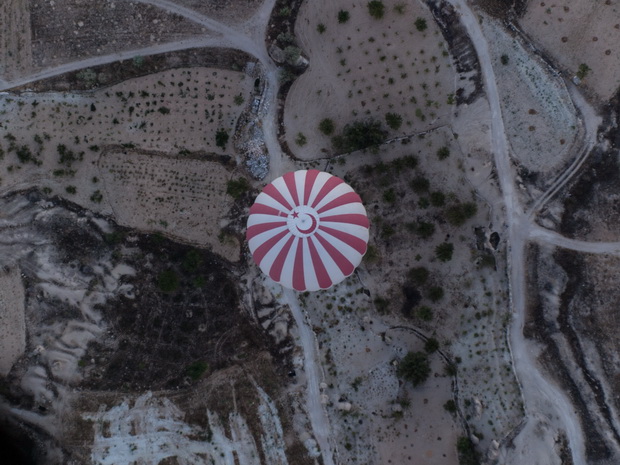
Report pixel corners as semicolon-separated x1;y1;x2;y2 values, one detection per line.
0;68;253;257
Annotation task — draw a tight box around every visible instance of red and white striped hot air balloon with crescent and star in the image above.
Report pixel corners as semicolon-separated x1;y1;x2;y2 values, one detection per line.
246;170;370;291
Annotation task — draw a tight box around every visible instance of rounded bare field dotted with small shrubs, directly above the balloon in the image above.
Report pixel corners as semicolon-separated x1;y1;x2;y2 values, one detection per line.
284;0;456;160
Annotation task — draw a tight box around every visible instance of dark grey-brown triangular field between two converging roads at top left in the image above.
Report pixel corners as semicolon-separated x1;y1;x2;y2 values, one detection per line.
30;0;206;67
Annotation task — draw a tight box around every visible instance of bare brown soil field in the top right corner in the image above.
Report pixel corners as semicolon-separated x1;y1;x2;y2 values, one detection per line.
519;0;620;101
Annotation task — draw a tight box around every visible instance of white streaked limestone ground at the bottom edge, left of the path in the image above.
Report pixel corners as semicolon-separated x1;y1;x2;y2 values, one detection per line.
82;385;288;465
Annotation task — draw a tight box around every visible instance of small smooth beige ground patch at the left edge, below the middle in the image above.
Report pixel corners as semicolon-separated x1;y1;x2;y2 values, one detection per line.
0;268;26;376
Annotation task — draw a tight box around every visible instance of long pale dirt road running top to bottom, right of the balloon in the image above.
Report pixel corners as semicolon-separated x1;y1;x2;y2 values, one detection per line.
450;0;586;465
